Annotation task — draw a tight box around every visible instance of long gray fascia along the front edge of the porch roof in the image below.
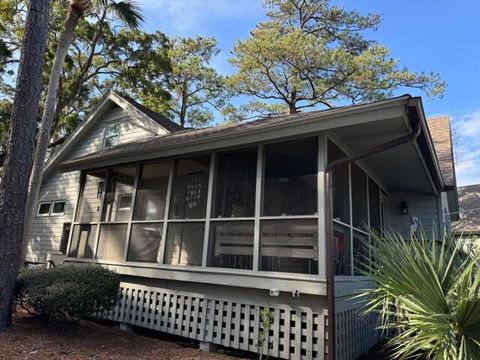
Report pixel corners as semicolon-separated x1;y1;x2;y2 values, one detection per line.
57;97;408;171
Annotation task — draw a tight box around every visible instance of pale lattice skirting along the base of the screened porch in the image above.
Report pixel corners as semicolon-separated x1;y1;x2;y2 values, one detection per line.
102;283;378;360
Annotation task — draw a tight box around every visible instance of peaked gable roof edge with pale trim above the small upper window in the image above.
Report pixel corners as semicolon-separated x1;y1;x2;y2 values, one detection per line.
43;91;183;175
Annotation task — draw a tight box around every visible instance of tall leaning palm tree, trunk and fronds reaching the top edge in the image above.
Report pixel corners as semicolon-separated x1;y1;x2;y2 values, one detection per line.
23;0;143;254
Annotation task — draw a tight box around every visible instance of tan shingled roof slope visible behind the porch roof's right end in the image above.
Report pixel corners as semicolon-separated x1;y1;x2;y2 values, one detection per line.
427;116;456;187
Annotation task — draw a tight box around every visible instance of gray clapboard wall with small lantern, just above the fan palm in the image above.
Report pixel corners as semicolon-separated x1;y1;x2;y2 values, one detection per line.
388;192;443;236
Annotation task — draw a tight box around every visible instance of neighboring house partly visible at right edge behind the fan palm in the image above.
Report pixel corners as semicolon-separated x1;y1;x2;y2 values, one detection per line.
452;184;480;251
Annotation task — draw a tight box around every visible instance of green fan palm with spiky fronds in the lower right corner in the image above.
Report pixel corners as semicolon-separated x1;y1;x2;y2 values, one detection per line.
359;229;480;360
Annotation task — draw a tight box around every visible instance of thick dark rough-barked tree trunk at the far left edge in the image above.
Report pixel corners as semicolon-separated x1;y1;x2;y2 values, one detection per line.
0;0;49;330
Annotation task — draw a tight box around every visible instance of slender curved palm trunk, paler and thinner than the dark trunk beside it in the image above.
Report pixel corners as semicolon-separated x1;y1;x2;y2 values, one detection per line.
22;5;83;259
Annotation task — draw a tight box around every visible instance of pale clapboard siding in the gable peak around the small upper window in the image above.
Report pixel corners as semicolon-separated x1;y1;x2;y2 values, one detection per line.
65;106;160;159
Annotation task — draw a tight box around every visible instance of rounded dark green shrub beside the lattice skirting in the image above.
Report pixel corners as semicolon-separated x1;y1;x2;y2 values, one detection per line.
16;265;120;319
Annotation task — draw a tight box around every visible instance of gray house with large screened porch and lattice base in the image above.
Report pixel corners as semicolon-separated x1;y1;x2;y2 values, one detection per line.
27;92;457;359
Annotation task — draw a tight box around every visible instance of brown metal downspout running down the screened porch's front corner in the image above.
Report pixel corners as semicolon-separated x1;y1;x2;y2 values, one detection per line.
325;120;421;360
